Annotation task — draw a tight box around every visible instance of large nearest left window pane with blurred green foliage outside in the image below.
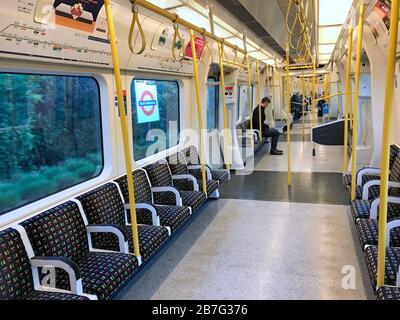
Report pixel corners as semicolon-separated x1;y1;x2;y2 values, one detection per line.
0;73;103;214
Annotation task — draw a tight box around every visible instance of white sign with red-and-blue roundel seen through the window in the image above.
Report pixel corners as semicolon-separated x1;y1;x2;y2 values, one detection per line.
135;80;160;124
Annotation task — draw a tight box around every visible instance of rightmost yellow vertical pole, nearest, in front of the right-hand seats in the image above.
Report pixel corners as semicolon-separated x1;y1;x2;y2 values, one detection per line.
377;0;399;288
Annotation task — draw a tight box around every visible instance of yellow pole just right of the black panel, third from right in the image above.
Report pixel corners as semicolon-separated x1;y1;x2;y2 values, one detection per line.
343;27;353;174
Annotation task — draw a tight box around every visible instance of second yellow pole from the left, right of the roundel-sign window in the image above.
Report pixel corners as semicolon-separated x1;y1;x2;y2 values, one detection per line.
190;29;206;194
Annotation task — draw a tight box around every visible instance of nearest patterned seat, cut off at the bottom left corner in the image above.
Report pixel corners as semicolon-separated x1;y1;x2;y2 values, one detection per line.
0;228;88;300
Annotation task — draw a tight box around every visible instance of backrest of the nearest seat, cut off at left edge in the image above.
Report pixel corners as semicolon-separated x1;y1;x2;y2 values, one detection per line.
0;228;34;300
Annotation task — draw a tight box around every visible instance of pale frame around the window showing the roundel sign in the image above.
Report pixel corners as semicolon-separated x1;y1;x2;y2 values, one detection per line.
130;74;184;162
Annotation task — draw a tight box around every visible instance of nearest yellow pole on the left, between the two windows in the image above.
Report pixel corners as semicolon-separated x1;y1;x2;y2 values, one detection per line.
104;0;140;260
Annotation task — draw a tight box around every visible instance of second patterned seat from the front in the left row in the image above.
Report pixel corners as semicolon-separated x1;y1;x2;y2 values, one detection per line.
21;201;138;300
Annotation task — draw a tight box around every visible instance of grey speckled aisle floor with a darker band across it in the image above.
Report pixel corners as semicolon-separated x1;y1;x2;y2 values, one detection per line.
117;122;375;300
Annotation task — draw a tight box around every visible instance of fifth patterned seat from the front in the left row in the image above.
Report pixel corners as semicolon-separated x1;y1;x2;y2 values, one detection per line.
144;160;207;213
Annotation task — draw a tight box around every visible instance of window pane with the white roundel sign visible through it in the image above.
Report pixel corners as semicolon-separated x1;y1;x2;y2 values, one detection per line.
131;79;180;161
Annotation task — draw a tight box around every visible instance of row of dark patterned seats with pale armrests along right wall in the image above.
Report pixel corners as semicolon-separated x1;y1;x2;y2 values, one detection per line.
343;145;400;300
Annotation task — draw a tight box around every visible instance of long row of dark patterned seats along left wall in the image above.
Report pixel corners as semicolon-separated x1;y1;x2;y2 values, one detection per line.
0;146;229;300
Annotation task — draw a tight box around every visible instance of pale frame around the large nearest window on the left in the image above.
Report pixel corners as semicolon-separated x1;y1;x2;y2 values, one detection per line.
0;66;113;229
